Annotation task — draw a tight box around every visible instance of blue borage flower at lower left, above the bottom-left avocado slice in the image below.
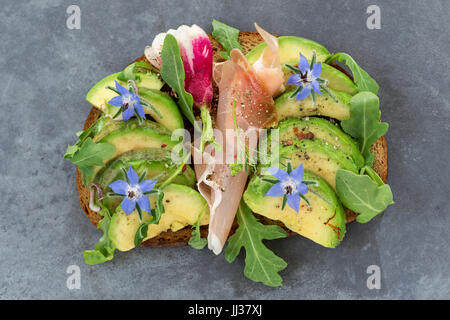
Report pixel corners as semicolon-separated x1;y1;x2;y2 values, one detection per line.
109;166;158;220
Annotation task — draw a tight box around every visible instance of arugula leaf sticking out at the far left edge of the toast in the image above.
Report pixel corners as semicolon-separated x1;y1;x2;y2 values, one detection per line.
70;137;116;176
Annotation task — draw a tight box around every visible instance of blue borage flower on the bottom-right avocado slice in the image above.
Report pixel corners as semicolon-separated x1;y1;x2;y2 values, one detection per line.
263;163;311;213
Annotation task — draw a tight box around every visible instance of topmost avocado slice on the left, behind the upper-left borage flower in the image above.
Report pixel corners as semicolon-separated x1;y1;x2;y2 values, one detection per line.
86;72;163;111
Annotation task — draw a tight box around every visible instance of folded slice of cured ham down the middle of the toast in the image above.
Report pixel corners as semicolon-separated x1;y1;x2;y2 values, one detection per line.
194;24;284;254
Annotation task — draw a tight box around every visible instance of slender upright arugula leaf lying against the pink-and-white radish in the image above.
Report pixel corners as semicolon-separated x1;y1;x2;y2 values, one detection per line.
161;34;198;128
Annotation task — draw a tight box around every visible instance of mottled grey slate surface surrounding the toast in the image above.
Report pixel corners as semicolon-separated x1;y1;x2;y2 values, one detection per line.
0;0;450;299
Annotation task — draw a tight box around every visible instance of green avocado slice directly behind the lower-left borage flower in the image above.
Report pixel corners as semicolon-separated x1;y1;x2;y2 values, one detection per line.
94;148;195;212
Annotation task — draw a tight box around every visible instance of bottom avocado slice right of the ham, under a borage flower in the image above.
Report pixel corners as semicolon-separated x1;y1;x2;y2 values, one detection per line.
244;171;346;248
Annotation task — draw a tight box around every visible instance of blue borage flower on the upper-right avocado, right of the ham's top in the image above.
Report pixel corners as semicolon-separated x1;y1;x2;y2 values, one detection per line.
286;52;330;103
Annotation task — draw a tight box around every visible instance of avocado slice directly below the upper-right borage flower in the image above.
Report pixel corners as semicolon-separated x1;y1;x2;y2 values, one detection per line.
275;89;351;120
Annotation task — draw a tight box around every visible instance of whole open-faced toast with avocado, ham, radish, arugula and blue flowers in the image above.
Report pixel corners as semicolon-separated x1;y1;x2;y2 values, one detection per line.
64;20;393;286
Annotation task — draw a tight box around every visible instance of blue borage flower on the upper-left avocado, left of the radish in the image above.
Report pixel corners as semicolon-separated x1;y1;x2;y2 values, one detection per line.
108;81;145;121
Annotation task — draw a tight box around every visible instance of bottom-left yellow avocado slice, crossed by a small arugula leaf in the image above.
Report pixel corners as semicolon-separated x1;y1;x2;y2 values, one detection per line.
108;183;209;251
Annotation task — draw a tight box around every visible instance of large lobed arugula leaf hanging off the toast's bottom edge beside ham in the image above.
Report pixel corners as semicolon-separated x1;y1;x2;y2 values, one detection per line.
225;201;287;287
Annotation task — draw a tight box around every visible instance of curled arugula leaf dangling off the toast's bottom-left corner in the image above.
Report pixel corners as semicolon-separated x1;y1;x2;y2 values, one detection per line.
83;208;116;265
